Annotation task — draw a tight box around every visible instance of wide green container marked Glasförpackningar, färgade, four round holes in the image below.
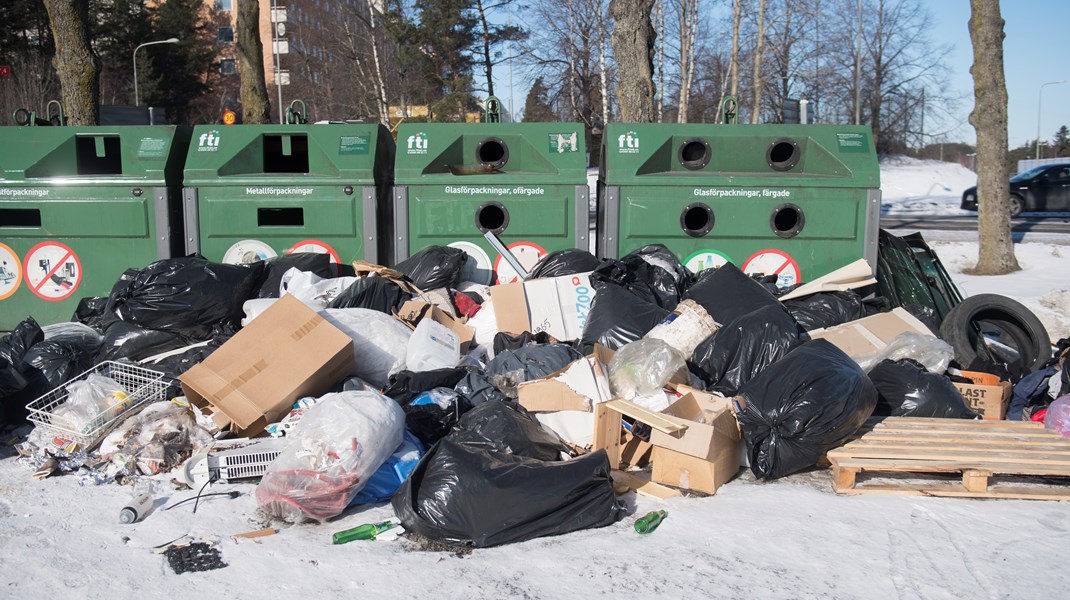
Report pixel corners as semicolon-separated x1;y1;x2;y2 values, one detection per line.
598;123;881;286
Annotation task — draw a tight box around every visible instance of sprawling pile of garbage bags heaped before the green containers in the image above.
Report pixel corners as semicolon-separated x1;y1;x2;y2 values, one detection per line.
0;233;1070;548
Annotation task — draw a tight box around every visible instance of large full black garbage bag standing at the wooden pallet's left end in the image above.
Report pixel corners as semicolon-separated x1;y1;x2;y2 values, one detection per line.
738;340;877;479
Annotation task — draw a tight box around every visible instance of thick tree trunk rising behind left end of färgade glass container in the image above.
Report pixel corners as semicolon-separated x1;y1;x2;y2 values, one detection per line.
609;0;656;123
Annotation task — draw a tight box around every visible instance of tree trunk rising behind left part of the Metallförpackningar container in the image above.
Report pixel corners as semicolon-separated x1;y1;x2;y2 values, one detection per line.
234;0;271;124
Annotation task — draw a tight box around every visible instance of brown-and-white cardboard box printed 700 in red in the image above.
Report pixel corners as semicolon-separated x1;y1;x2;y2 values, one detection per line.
490;273;595;341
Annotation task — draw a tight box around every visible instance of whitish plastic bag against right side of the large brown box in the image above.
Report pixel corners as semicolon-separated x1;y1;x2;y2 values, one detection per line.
320;308;412;387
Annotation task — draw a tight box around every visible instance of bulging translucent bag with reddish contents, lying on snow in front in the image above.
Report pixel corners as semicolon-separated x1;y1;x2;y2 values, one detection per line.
256;391;404;523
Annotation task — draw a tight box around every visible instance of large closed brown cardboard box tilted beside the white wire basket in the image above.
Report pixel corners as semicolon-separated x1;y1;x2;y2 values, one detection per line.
179;295;354;437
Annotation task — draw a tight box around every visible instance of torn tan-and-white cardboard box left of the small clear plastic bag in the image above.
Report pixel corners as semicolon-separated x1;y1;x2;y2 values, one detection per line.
517;345;613;413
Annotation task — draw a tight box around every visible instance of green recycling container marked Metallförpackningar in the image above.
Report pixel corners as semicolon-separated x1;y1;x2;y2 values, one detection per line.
183;123;394;264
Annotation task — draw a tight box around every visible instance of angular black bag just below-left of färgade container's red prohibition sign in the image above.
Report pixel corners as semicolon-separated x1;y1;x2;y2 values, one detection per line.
680;262;780;325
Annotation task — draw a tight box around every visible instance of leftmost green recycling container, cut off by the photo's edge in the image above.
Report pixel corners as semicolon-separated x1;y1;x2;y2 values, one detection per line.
0;126;189;330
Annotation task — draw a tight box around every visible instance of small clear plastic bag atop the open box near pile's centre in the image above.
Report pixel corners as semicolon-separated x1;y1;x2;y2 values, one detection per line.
609;338;688;400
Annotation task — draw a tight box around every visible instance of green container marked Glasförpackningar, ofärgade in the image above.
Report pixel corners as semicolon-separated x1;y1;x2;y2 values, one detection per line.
394;123;591;284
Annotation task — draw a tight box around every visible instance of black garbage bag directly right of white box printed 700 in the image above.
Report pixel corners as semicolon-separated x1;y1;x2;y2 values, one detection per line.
581;284;671;351
